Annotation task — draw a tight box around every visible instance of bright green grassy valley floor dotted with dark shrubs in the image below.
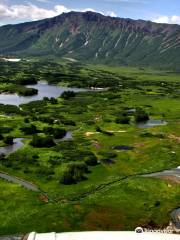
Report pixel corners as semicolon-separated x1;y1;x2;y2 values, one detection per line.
0;61;180;235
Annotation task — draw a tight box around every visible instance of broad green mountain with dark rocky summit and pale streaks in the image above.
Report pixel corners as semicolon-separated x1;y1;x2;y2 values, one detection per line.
0;12;180;70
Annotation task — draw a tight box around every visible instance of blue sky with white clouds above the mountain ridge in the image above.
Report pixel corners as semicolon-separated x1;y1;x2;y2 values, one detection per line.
0;0;180;25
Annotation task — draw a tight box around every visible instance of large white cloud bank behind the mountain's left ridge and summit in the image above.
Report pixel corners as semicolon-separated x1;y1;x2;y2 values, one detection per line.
0;0;117;24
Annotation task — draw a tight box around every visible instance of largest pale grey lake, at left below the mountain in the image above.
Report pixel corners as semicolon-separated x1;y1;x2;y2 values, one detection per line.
0;81;86;106
